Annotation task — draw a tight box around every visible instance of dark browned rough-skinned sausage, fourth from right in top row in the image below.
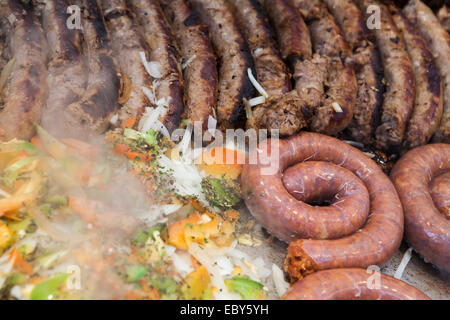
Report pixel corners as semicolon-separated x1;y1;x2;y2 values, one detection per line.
324;0;383;144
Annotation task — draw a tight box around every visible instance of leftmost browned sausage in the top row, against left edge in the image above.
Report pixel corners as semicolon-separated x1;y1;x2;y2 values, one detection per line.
0;0;47;140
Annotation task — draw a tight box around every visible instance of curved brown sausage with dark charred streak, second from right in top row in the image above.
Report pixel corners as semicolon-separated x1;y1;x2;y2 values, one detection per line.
390;6;443;149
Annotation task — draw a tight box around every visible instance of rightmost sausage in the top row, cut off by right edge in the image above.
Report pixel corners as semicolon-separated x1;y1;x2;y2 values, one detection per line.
403;0;450;143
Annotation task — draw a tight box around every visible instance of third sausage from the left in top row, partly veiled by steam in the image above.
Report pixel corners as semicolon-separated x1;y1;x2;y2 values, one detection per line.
66;0;120;135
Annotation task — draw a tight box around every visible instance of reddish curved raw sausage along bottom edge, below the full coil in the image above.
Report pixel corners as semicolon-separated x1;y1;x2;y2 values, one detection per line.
283;268;430;300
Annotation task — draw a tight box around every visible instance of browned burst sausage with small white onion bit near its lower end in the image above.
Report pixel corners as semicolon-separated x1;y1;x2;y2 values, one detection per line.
293;0;357;135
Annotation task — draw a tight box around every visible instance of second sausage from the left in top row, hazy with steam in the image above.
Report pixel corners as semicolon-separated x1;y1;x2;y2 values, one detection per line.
41;0;87;135
